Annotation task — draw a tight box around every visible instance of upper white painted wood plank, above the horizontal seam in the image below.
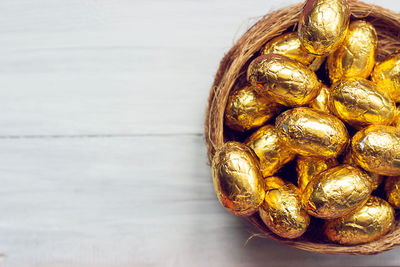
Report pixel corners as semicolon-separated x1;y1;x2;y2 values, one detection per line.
0;0;399;135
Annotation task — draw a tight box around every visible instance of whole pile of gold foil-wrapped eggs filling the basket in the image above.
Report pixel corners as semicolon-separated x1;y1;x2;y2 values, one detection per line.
212;0;400;245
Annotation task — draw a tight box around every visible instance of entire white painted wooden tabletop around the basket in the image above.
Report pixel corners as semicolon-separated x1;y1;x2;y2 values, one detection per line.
0;0;400;266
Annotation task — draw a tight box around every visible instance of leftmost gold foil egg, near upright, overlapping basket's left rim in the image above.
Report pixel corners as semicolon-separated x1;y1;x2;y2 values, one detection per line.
212;142;265;216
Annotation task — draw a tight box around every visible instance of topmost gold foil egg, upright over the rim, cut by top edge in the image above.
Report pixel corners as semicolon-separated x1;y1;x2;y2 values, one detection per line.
298;0;350;56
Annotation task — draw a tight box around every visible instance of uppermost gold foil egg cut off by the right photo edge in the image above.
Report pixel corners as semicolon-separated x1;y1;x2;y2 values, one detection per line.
371;53;400;102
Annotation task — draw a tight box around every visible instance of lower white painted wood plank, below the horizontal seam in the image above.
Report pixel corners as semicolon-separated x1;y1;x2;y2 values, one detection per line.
0;136;400;266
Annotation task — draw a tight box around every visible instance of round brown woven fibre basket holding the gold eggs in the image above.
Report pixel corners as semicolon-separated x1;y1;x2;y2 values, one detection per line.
205;0;400;255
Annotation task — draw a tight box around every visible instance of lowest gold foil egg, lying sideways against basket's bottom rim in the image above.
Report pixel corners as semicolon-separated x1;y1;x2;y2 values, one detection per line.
324;196;394;245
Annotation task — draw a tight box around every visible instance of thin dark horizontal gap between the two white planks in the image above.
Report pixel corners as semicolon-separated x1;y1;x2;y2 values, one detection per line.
0;133;203;139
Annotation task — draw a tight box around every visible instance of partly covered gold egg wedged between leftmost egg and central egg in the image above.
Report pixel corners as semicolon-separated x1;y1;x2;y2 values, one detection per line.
245;125;295;177
